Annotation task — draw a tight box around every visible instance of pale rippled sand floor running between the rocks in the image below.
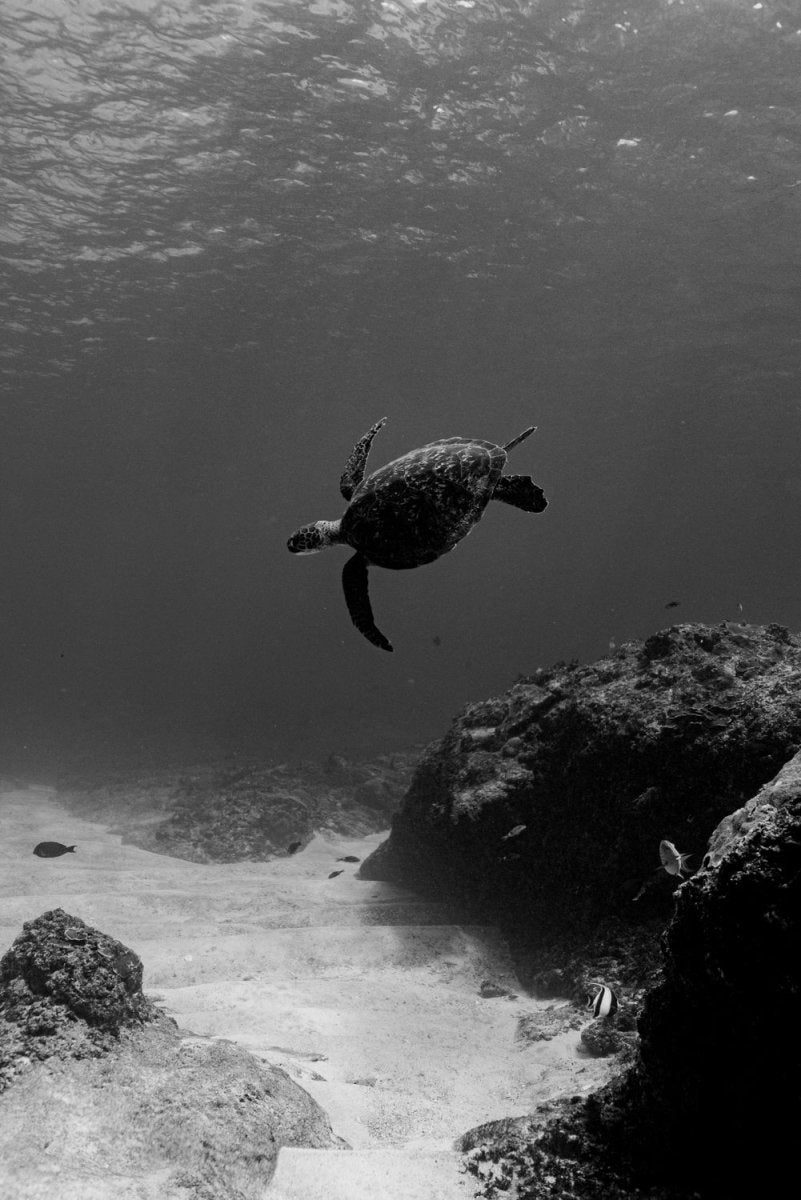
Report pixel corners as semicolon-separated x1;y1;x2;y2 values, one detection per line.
0;788;613;1200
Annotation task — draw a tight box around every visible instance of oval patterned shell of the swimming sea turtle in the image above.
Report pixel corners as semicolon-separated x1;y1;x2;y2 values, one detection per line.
341;438;506;570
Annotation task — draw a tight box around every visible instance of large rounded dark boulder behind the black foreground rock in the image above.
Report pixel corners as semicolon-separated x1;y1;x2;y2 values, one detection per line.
360;623;801;1000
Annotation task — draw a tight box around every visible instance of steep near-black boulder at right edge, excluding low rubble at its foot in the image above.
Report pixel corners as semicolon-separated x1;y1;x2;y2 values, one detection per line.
613;754;801;1195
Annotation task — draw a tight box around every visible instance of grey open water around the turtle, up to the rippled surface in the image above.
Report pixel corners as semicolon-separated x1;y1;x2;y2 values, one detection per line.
0;0;801;776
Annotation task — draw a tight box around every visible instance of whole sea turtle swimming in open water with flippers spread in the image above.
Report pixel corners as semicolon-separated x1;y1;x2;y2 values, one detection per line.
287;418;548;650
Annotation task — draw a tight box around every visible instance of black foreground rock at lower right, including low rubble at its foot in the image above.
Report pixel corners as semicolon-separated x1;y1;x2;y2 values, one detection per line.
462;754;801;1200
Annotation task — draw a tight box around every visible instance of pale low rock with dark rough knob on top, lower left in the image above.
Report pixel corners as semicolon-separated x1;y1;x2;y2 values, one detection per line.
0;908;342;1200
